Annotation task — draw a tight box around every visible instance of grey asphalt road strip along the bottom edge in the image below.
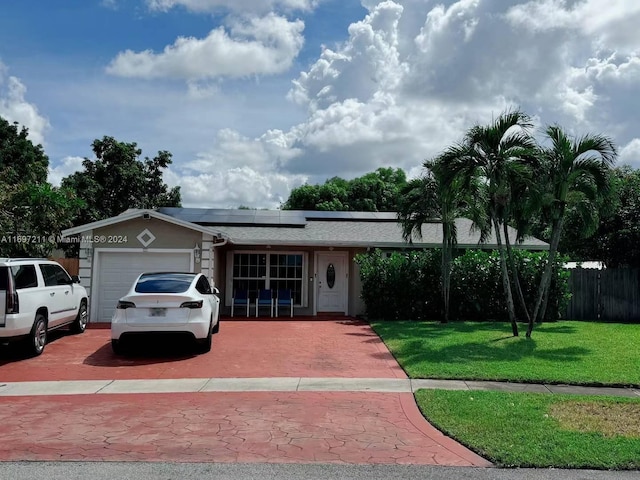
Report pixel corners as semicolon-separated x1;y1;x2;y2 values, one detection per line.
0;462;640;480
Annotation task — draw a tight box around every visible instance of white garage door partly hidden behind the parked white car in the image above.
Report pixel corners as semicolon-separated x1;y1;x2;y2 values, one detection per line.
91;252;191;322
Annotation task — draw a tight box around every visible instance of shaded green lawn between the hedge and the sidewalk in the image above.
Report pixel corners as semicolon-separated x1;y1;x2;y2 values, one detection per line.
372;321;640;386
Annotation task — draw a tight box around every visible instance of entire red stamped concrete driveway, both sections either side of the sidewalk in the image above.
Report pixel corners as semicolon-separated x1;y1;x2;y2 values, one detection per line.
0;321;490;466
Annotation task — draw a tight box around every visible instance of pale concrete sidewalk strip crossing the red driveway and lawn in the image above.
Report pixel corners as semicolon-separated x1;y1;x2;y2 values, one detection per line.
0;377;640;398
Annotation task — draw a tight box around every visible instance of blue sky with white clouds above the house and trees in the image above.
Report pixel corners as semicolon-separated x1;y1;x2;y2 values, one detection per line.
0;0;640;208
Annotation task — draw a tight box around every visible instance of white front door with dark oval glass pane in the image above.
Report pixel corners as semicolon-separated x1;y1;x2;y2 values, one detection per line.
316;252;348;314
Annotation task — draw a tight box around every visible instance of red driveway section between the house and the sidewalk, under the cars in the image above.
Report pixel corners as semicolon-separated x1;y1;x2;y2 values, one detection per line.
0;320;406;382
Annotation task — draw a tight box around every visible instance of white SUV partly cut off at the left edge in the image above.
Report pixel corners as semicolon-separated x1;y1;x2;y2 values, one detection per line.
0;258;88;355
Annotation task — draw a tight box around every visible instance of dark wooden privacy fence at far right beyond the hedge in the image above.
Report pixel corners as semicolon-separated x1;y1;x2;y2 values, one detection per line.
567;268;640;323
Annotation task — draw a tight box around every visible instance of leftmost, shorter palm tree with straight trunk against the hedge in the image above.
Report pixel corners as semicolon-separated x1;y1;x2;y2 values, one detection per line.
398;160;466;323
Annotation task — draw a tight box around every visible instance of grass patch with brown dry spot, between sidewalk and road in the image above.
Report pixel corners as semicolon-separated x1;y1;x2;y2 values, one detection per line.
416;390;640;470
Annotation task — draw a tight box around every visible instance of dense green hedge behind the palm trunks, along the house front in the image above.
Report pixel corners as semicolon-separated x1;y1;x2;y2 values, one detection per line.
356;249;571;320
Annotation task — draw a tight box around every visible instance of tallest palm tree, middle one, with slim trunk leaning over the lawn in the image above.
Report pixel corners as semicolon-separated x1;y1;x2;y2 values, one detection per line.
440;110;536;336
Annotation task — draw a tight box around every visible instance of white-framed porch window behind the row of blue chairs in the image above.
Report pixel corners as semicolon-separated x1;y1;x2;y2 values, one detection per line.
232;252;304;306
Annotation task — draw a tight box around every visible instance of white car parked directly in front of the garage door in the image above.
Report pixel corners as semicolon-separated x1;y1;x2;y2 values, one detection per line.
111;272;220;354
